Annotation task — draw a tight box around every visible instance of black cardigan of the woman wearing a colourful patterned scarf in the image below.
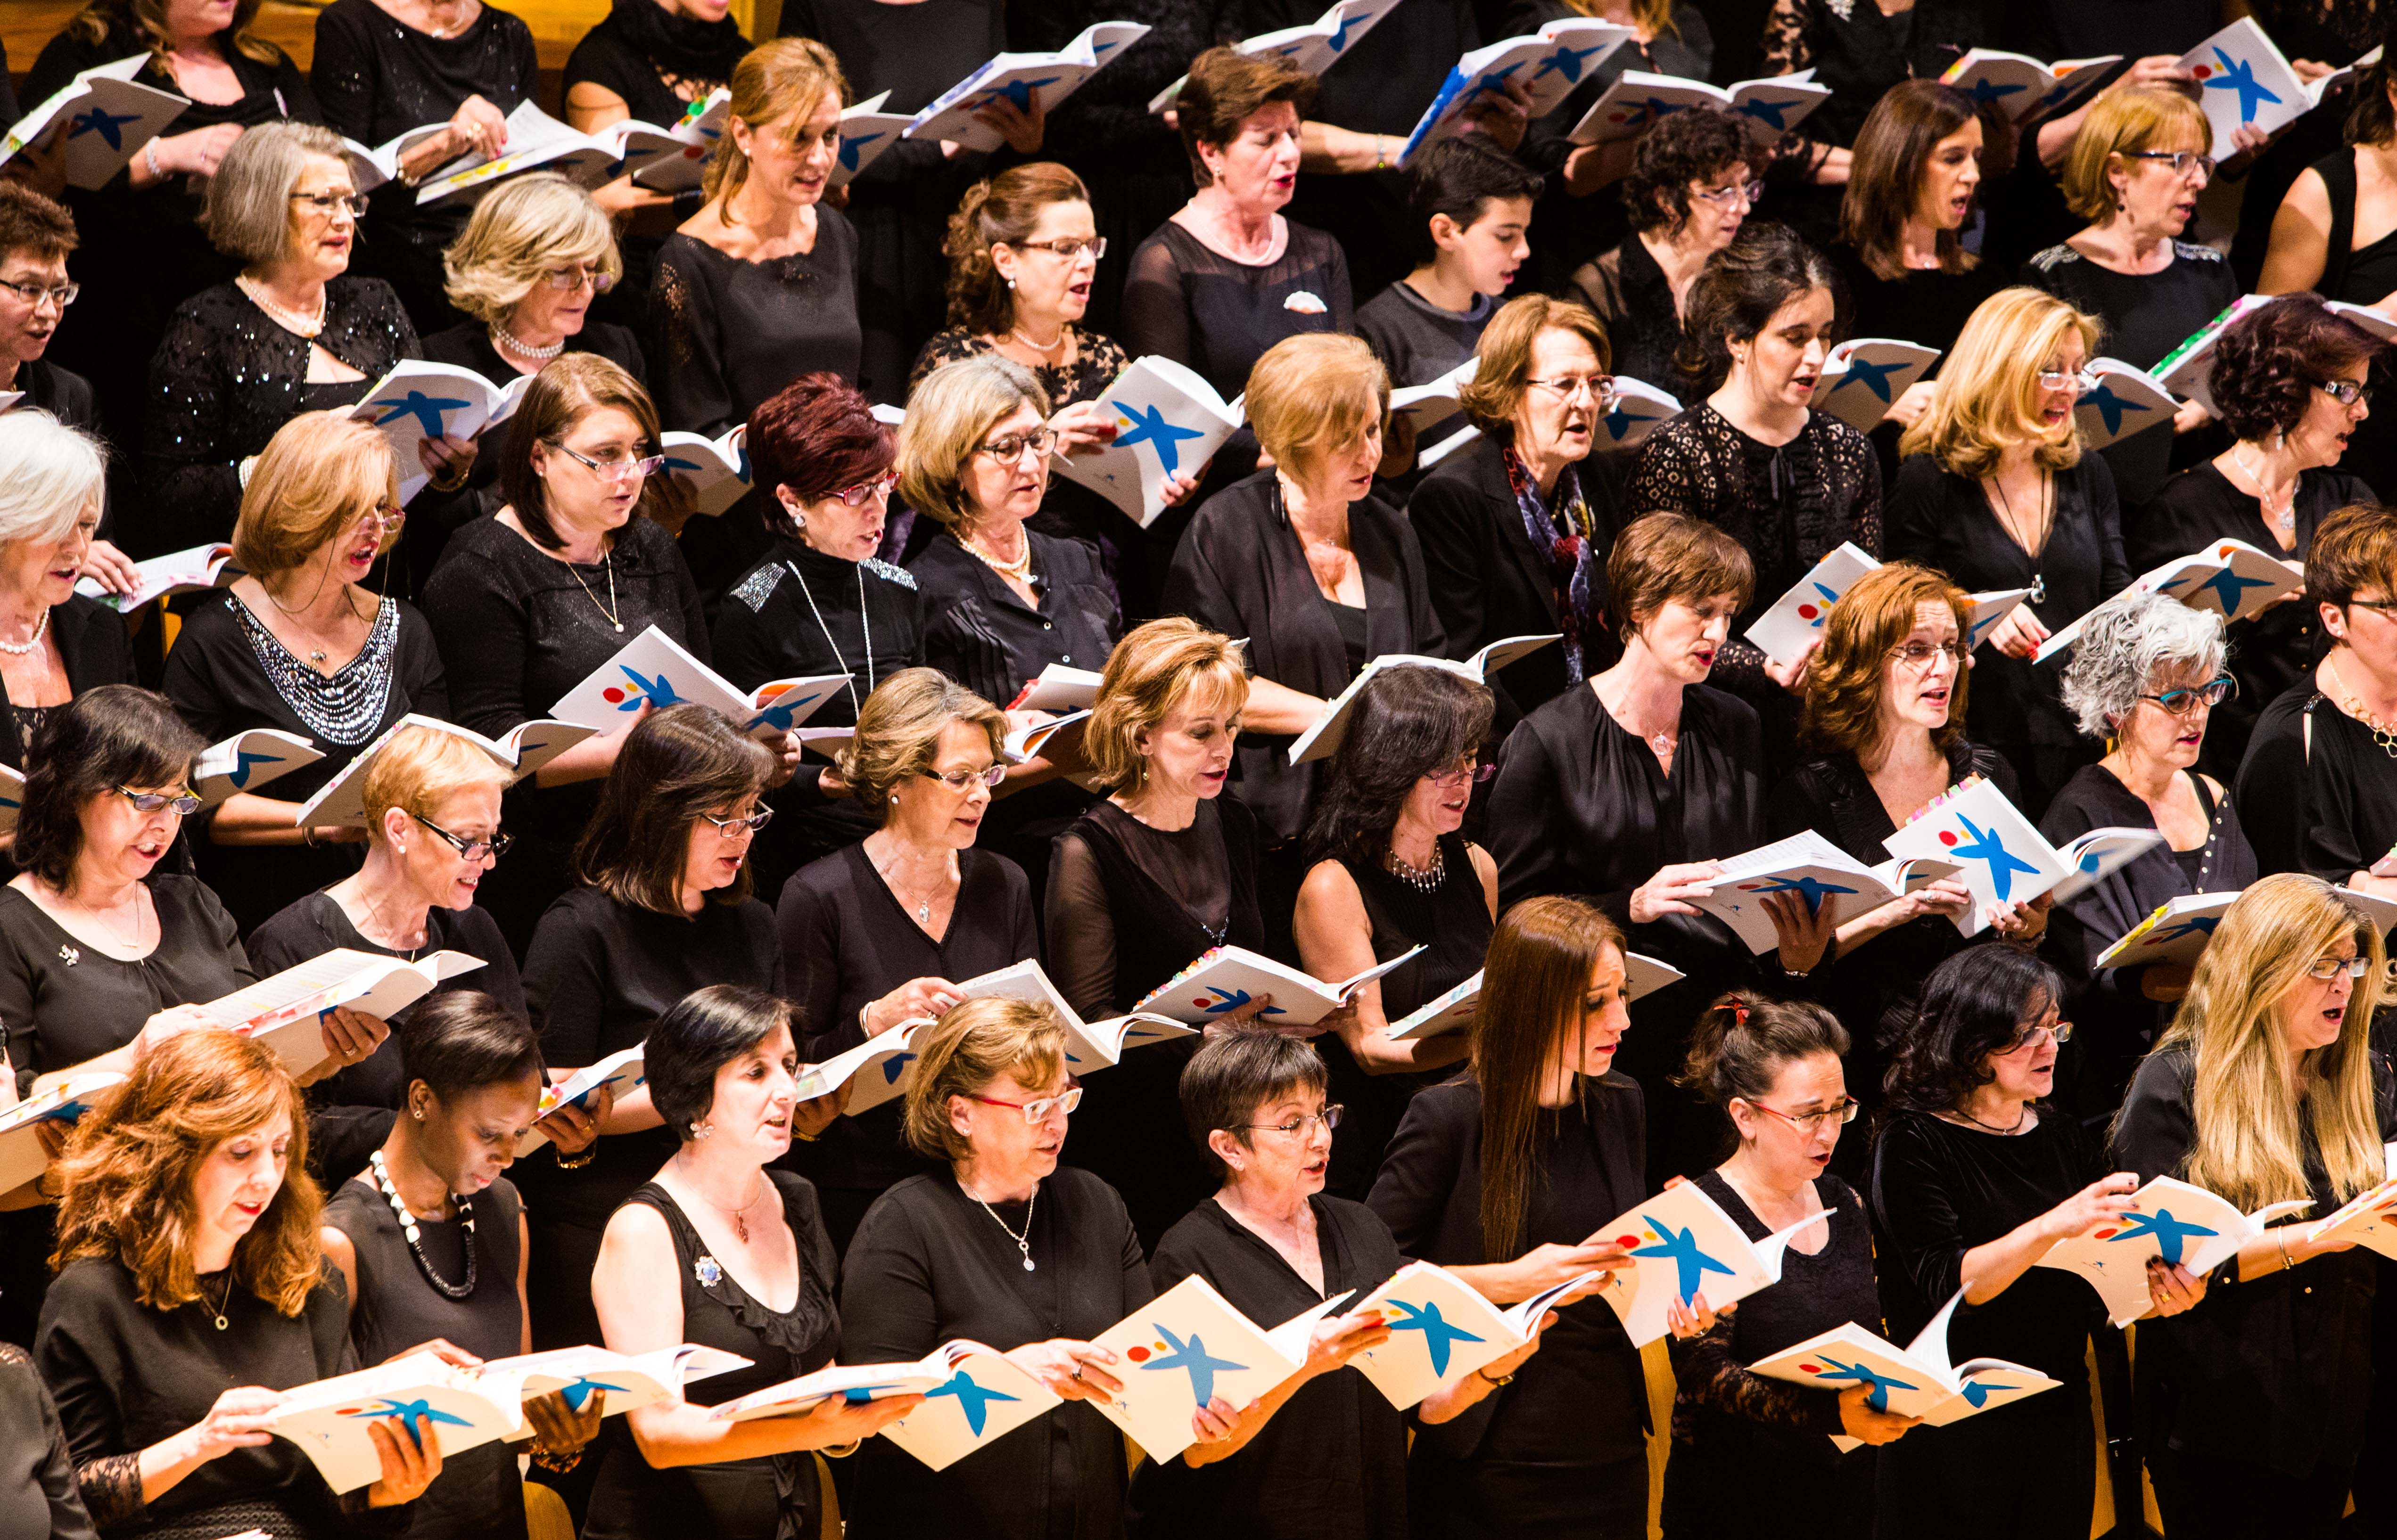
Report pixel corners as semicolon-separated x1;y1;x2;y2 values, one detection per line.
1407;438;1623;740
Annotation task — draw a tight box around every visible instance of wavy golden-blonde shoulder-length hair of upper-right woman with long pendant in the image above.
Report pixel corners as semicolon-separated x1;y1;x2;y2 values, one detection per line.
1898;287;2102;476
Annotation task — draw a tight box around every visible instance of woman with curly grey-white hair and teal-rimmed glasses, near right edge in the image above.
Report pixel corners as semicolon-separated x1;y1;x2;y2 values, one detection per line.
2040;594;2256;1116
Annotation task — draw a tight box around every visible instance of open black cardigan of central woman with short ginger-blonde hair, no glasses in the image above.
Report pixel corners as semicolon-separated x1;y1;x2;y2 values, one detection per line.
1162;469;1448;845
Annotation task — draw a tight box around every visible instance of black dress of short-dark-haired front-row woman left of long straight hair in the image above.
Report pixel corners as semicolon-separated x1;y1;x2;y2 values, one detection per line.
1131;1197;1407;1540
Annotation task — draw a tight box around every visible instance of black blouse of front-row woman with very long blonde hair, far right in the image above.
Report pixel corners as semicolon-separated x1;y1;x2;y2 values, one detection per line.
2114;1044;2397;1480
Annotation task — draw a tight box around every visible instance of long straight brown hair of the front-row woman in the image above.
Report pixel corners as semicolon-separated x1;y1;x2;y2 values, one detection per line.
1472;898;1623;1262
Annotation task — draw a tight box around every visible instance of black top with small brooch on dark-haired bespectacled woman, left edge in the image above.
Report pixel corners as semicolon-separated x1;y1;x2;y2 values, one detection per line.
0;872;259;1092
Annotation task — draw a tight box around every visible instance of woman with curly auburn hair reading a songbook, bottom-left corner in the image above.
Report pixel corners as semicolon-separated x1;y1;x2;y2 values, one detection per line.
38;1030;441;1540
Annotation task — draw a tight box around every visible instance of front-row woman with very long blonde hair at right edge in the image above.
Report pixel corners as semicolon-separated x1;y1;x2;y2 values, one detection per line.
2114;872;2397;1540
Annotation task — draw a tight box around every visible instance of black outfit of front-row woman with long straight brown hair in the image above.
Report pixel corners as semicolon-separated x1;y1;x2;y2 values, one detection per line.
1371;1071;1649;1540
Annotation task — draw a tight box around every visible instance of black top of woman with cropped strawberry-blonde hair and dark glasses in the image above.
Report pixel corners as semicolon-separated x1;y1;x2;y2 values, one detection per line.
249;893;527;1188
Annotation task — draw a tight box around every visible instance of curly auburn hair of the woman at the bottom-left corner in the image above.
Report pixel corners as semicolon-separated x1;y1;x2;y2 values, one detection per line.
50;1027;323;1317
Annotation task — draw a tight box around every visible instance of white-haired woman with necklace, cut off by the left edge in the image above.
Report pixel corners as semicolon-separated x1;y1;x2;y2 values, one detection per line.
0;410;134;769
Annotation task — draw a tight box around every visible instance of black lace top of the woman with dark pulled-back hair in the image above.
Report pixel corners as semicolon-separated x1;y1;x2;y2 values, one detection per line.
1623;400;1882;699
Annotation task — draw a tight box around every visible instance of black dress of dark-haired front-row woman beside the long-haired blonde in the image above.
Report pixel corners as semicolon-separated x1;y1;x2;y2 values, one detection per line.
1872;1106;2100;1540
